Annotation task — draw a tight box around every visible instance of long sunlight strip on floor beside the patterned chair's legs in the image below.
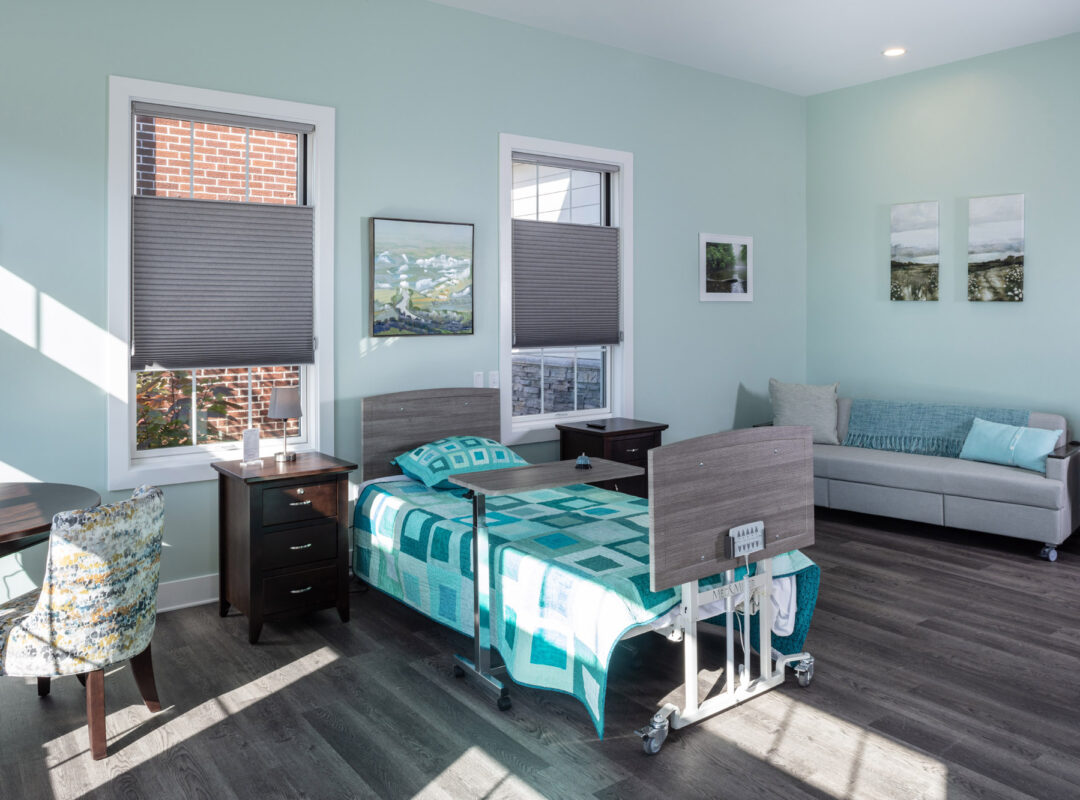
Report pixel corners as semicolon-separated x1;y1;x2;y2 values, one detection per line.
44;647;339;800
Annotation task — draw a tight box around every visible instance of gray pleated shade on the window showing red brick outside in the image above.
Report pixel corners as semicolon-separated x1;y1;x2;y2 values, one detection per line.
131;196;314;369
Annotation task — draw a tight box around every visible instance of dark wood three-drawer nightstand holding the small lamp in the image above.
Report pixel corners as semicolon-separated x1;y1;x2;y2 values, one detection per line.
211;452;356;645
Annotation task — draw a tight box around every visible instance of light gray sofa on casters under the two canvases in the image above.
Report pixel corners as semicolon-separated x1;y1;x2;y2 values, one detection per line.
813;397;1080;560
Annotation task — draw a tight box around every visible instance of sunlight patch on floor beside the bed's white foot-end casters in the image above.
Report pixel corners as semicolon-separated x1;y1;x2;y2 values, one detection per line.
704;687;948;800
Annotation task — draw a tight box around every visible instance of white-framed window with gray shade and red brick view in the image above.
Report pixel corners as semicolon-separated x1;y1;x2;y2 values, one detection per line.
109;79;333;488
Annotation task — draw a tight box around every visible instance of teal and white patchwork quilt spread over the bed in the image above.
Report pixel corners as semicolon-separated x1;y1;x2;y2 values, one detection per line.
354;480;819;736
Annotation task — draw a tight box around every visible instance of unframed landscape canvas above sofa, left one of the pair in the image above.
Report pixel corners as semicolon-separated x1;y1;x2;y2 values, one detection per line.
889;200;941;300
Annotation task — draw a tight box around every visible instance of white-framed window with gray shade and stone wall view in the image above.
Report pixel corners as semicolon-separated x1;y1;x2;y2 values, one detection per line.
502;136;632;442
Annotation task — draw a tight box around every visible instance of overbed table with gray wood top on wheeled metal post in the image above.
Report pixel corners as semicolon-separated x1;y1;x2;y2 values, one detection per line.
449;459;645;711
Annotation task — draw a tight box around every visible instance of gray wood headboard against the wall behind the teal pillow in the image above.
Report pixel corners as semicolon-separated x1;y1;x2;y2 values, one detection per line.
360;389;501;480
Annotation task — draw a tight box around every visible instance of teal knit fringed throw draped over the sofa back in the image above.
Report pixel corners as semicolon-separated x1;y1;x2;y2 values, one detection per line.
843;399;1030;458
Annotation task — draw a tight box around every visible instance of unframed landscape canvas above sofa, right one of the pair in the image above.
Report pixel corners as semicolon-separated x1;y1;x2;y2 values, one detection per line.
968;194;1024;302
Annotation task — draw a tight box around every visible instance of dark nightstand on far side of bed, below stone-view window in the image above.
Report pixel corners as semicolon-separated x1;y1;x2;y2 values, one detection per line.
555;417;667;498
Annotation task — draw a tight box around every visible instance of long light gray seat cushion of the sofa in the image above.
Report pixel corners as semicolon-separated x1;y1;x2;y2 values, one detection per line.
813;445;1066;509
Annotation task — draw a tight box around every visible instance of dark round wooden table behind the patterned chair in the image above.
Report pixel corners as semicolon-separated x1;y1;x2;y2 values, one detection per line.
0;484;102;556
